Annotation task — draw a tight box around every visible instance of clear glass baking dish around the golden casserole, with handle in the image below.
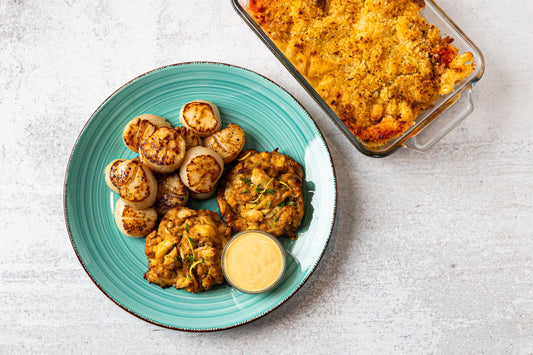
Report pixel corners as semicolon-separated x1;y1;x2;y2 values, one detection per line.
231;0;485;157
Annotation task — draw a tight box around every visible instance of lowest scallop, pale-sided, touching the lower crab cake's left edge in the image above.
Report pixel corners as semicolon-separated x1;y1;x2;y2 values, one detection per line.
115;200;157;238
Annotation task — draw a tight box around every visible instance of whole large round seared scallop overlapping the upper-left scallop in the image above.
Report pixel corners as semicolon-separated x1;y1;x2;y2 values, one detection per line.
139;127;186;173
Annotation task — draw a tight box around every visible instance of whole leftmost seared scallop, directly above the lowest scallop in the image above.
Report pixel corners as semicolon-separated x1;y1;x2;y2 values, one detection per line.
106;158;157;209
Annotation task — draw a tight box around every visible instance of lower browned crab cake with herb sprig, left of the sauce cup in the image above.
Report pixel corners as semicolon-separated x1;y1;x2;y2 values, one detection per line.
144;207;231;292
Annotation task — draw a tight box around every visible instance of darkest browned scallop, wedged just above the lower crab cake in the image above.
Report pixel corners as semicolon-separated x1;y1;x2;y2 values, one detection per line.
155;171;189;215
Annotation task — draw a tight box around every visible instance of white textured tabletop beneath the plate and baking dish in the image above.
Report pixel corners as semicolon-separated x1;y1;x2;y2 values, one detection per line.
0;0;533;354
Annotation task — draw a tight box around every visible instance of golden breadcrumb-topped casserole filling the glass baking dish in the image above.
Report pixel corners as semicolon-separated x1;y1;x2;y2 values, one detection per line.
250;0;474;146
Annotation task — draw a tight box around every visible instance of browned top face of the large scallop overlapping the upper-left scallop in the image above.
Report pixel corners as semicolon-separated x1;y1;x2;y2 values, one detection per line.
139;127;185;165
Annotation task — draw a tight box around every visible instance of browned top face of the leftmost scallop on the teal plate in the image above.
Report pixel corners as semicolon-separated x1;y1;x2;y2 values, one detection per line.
109;158;152;202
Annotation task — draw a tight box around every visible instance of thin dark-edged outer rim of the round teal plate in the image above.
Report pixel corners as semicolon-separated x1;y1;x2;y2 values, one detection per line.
63;61;338;333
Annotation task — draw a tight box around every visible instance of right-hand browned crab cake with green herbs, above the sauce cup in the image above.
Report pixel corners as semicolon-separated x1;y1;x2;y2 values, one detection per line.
217;149;304;238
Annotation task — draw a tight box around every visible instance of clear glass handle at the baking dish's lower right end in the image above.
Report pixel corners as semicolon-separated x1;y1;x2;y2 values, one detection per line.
404;85;474;152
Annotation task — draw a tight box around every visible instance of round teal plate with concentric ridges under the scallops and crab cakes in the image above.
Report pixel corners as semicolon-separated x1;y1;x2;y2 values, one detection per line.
64;62;337;331
